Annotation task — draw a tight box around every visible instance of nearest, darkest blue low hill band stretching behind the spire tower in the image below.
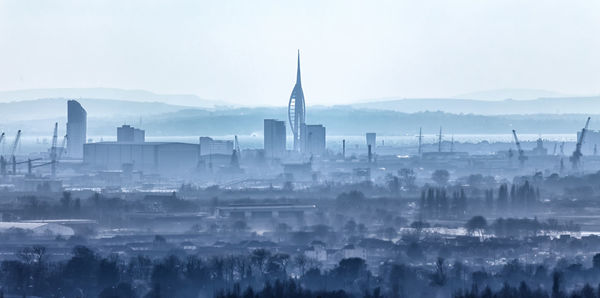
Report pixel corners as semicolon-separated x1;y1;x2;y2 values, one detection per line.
97;107;600;136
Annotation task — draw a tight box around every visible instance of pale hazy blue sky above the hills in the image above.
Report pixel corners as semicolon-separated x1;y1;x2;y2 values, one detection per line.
0;0;600;105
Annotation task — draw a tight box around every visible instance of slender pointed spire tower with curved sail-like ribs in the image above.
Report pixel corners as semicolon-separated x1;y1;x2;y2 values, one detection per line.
288;50;306;151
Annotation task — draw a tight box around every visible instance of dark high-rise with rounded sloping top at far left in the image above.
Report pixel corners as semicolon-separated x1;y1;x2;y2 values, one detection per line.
67;100;87;159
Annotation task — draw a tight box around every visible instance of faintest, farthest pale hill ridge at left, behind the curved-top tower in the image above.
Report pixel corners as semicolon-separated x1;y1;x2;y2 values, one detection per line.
0;88;226;108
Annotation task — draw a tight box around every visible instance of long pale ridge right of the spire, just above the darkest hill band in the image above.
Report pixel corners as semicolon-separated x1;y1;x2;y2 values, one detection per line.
350;96;600;115
